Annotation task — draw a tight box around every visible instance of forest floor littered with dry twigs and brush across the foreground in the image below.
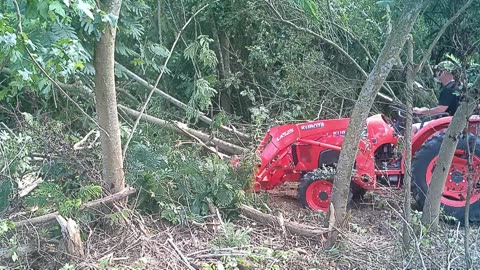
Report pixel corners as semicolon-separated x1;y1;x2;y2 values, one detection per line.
15;182;480;269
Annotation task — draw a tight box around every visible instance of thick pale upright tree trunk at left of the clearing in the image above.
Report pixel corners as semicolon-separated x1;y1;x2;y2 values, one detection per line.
94;0;125;193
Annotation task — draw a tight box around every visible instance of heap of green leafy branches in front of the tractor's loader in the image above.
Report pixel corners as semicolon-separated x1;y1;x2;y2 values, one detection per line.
127;139;249;223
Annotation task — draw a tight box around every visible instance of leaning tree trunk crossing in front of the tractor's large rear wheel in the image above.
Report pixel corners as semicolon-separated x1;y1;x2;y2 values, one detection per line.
422;76;480;230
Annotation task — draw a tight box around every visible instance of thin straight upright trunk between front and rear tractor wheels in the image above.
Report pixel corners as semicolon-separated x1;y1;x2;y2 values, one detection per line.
403;36;415;253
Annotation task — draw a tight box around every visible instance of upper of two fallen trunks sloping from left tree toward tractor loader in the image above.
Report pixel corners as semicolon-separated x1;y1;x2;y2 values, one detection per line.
115;62;250;140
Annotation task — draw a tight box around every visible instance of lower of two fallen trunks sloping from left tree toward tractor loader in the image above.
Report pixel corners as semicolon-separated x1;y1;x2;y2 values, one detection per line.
118;104;247;155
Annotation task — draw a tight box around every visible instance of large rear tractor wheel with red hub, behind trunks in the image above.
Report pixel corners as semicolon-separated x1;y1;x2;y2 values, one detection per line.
412;133;480;223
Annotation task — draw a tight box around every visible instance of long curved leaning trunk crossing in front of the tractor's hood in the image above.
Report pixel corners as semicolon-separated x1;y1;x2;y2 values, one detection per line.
328;0;424;246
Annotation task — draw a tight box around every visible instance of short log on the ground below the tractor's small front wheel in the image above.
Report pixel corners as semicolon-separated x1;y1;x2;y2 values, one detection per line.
240;205;331;238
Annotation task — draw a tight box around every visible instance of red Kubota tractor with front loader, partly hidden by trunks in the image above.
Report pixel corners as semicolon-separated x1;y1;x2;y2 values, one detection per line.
253;109;480;222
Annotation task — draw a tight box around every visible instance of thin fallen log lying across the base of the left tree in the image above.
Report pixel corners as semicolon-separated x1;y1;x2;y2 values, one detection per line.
13;187;136;228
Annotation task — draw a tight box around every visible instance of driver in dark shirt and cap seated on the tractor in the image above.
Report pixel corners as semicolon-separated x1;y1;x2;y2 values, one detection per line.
412;61;461;134
